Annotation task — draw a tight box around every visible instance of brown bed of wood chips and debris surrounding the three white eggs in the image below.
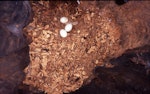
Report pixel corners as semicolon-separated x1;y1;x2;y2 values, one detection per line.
24;1;150;94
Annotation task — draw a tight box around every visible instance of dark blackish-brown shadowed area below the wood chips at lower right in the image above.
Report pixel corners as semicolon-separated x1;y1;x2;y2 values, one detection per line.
64;46;150;94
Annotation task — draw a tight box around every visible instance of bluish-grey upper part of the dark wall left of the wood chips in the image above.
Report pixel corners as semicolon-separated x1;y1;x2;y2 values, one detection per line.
0;1;32;57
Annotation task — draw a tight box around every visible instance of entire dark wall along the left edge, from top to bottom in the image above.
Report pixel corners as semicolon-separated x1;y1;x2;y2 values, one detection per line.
0;1;32;94
